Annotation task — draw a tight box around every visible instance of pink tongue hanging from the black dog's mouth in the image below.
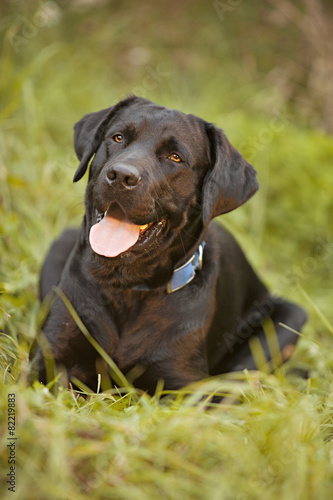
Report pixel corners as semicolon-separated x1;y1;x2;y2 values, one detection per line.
89;212;140;257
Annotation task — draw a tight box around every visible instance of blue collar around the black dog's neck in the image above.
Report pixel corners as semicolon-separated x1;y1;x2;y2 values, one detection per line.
132;241;206;293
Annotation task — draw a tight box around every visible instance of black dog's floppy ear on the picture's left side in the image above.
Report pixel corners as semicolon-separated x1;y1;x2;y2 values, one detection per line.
73;106;115;182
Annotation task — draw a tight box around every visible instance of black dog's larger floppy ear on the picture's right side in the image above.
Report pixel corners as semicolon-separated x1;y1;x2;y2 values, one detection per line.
202;124;259;226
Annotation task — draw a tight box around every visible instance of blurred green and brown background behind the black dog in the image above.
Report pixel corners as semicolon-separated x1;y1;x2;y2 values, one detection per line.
0;0;333;352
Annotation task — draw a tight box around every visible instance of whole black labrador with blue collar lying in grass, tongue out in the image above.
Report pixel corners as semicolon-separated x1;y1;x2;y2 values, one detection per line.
32;96;306;393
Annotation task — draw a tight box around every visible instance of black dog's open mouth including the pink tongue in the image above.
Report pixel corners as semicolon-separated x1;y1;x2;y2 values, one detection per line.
89;206;167;257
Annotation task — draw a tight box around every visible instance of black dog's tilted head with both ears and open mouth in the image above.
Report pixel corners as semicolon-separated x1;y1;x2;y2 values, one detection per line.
74;96;258;259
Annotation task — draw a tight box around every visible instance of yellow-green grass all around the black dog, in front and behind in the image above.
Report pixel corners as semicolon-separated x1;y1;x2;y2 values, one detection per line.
0;2;333;500
